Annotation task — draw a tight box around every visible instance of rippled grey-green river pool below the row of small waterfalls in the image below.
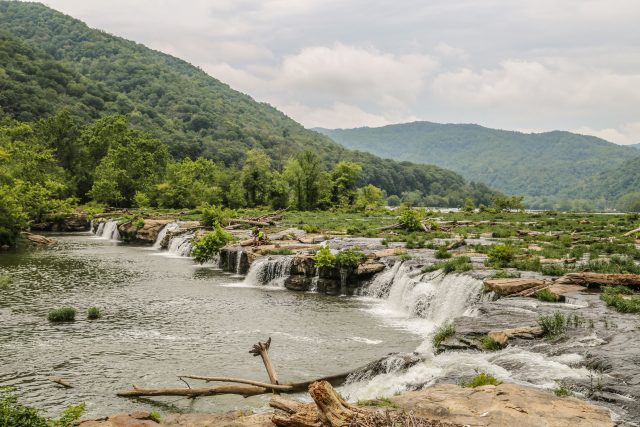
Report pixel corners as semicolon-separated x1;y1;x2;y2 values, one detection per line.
0;234;422;416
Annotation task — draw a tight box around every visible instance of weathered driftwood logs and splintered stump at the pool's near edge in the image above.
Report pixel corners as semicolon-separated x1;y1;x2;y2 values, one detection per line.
118;338;455;427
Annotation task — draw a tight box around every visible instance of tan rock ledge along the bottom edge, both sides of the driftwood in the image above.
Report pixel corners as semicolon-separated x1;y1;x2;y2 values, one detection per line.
80;384;614;427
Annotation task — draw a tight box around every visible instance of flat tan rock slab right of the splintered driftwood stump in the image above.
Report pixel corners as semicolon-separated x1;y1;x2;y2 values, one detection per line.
391;384;613;427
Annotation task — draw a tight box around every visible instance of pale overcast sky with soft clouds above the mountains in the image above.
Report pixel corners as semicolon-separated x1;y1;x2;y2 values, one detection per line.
35;0;640;144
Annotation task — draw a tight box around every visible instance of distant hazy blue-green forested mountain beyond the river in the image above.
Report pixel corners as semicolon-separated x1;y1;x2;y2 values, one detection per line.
317;122;640;211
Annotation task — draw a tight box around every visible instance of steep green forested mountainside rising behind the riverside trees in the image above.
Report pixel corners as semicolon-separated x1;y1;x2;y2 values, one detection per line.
0;1;490;205
